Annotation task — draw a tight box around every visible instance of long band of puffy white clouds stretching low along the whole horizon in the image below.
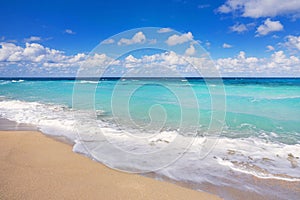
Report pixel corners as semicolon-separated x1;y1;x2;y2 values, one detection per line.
0;41;300;76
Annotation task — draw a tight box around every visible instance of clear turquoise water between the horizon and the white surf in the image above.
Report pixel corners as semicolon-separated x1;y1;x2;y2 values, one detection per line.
0;79;300;144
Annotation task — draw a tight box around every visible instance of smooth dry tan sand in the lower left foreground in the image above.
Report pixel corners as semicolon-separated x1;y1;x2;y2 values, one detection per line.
0;131;220;200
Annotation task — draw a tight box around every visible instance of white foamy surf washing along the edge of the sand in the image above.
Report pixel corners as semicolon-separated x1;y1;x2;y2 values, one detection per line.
0;99;300;197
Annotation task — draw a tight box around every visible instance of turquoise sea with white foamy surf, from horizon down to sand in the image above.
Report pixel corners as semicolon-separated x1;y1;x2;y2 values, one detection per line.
0;78;300;199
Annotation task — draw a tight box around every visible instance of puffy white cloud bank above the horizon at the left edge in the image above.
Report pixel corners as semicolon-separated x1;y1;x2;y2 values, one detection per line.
0;43;125;76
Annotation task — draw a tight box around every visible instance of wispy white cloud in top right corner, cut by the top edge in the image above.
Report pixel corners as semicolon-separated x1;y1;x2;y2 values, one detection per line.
218;0;300;18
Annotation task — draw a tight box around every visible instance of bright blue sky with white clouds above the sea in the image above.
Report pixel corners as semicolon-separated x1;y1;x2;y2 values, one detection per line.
0;0;300;77
